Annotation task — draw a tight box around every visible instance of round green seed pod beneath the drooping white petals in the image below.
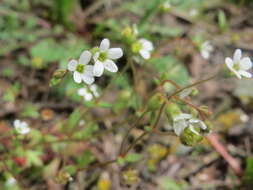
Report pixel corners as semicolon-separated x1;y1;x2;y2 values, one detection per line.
180;125;203;146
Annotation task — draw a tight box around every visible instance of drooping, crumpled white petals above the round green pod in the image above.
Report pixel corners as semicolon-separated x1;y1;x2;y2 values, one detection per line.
173;113;207;136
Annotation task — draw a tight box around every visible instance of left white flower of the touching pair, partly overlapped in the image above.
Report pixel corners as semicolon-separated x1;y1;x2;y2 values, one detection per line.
68;51;94;84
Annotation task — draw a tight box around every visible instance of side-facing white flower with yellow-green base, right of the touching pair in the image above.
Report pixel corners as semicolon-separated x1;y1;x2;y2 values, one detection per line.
132;38;154;59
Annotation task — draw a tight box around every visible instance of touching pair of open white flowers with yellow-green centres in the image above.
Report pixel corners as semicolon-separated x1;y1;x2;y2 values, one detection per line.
68;39;123;85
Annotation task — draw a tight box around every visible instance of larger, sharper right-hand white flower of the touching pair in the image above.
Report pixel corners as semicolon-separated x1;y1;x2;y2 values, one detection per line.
93;39;123;77
